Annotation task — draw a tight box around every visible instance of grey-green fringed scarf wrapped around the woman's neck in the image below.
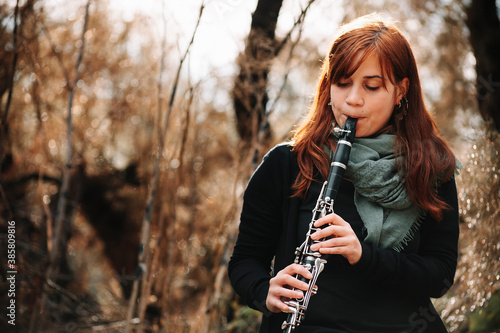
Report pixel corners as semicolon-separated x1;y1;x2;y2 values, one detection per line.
334;134;425;252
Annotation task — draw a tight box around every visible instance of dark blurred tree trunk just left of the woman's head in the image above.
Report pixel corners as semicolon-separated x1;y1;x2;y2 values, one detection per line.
233;0;283;144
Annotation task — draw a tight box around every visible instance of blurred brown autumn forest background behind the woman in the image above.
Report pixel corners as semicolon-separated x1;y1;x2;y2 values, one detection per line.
0;0;500;332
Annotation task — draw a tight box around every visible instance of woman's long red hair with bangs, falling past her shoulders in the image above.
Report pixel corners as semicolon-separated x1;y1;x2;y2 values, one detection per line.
293;15;456;220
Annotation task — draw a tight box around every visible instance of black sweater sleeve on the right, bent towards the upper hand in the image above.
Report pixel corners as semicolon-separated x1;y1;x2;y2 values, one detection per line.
353;179;459;297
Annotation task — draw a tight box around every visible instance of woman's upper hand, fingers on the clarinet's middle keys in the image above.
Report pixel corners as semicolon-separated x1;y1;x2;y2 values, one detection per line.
311;213;362;265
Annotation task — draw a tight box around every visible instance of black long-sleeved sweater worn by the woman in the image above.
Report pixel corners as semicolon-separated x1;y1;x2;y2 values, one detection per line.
229;144;459;333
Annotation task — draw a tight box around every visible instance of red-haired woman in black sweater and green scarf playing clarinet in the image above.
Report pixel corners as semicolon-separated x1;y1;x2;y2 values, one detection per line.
229;15;459;333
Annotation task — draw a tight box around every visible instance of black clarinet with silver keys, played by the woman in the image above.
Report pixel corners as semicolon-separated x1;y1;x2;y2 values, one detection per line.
281;117;358;333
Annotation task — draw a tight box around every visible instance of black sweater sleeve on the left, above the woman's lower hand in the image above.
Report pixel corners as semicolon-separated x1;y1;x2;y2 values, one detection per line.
228;144;288;313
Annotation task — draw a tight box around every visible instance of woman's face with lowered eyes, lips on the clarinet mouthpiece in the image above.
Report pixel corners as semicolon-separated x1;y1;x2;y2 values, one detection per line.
330;54;408;137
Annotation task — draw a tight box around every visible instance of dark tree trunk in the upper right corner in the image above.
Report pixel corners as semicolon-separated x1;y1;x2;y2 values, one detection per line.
466;0;500;132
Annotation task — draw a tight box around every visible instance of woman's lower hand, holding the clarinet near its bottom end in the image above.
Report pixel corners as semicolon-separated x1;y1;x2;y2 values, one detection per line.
266;264;312;313
